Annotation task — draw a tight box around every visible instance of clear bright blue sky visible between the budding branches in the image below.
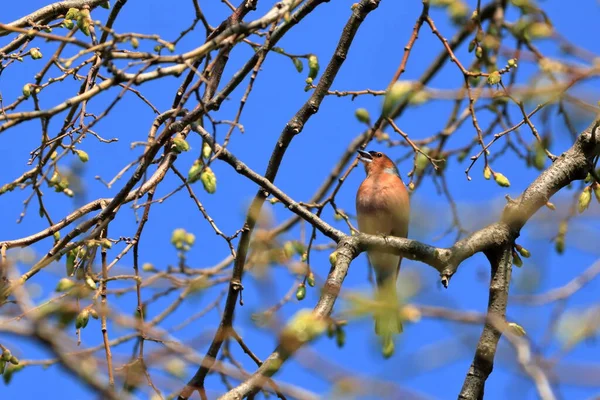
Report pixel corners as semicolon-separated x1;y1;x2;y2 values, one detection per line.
0;0;600;399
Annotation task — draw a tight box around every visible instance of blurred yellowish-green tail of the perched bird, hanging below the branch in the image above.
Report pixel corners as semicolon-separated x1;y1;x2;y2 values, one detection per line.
374;271;403;358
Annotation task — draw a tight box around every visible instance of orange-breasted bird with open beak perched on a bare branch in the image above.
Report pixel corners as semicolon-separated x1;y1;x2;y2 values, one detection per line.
356;150;410;358
